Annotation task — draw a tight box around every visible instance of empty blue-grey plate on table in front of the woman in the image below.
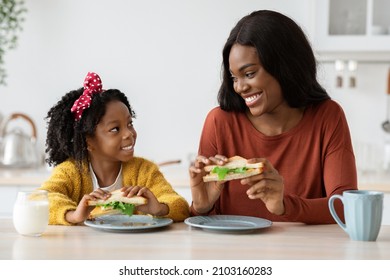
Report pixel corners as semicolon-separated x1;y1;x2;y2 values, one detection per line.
184;215;272;232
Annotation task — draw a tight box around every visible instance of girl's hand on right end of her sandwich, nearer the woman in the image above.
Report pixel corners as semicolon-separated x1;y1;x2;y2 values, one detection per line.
121;186;169;216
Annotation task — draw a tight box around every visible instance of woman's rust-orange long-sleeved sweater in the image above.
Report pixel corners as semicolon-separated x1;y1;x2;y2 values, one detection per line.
191;100;357;224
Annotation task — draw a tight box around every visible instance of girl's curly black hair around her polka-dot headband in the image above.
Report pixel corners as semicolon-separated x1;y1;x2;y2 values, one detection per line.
45;88;135;168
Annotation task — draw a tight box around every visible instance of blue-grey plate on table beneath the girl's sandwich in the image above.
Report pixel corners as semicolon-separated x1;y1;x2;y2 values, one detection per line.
84;215;173;232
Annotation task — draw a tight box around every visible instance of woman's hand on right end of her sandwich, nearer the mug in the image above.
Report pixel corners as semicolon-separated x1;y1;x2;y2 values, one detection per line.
241;159;285;215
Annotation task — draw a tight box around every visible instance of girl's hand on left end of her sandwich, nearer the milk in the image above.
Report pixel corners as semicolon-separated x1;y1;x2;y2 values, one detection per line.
65;189;111;224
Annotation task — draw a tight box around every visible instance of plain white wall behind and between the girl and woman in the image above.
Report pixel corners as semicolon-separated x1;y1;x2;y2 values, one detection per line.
0;0;309;165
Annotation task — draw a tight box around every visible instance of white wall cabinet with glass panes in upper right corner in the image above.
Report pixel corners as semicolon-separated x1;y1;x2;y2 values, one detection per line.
313;0;390;61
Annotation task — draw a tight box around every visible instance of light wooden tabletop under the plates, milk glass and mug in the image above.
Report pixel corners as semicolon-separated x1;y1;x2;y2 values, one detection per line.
0;218;390;260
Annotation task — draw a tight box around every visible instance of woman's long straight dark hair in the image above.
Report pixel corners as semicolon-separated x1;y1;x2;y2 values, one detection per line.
218;10;330;112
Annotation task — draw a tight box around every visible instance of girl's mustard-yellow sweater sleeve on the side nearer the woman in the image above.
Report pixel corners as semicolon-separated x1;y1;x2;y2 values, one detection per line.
125;160;189;222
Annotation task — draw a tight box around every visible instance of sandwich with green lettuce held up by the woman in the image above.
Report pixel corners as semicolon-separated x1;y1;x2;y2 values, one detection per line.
203;156;264;182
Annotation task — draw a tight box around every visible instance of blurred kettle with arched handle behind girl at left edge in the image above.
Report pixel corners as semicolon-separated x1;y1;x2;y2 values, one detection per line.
0;113;40;168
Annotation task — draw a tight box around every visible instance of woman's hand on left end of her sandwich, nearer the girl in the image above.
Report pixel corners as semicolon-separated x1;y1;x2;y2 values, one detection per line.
189;155;228;214
